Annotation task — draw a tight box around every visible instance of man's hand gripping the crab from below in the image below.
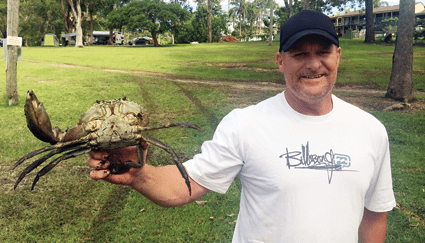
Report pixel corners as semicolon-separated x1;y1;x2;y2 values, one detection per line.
87;141;149;185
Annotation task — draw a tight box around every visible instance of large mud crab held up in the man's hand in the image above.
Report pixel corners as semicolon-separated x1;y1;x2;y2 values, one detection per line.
13;90;202;194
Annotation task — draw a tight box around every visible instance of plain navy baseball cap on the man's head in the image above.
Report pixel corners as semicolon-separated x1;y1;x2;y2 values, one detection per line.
279;10;339;52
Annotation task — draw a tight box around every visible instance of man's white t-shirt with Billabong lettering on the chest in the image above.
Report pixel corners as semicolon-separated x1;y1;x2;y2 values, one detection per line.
184;93;395;243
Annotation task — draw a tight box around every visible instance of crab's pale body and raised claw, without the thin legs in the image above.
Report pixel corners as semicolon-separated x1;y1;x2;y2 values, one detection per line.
25;90;149;149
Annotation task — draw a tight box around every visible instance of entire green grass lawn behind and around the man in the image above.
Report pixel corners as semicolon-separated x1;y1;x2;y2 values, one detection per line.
0;40;425;242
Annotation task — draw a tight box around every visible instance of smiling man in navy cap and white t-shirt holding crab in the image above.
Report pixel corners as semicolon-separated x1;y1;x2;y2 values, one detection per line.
88;10;395;243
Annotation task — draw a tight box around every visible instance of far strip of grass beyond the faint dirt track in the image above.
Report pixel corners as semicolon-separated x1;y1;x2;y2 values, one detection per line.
22;39;425;90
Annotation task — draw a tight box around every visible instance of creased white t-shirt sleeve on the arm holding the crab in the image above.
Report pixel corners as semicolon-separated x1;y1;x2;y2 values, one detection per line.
183;111;243;193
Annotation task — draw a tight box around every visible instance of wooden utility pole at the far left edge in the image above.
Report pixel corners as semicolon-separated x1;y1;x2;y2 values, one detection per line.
6;0;19;105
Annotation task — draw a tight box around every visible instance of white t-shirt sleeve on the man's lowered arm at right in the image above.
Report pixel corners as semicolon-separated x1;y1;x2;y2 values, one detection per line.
365;125;396;212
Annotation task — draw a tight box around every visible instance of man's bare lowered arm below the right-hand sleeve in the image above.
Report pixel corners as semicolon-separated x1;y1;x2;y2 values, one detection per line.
359;208;387;243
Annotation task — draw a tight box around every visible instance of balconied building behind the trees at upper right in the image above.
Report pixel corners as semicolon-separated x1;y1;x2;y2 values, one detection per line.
329;2;425;37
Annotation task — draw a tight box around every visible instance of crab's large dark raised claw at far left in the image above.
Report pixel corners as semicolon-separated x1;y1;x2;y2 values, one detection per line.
24;90;62;144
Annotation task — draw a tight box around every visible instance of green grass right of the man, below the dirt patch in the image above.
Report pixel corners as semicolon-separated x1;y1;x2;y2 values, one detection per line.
373;111;425;242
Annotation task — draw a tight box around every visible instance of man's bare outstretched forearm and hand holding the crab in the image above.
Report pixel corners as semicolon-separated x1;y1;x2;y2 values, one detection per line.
87;147;209;207
